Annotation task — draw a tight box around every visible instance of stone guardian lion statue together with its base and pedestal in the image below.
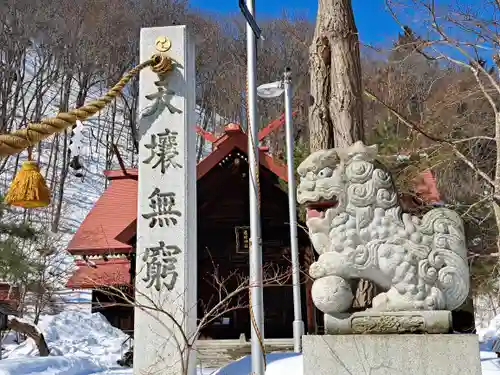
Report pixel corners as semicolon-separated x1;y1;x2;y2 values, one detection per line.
297;142;481;375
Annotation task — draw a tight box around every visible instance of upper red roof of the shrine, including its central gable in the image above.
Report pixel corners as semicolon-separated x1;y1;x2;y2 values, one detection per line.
68;124;288;255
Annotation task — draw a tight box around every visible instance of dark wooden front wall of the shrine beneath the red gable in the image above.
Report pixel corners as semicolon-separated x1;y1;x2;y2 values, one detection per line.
198;153;309;339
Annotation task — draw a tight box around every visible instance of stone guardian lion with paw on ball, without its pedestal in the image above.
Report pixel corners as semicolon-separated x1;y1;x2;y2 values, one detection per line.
297;142;469;316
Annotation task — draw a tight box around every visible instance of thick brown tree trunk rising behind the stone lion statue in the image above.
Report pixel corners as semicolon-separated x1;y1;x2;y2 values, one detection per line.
309;0;377;309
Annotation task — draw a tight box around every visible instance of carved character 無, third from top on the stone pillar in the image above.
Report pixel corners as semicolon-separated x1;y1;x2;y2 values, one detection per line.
142;188;181;228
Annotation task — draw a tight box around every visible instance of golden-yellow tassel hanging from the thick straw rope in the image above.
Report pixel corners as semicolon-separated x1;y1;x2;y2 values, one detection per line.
4;161;50;208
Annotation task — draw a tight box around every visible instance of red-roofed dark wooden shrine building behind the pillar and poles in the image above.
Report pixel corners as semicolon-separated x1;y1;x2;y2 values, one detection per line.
67;119;321;339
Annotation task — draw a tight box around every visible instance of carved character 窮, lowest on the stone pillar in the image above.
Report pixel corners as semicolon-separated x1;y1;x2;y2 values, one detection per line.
142;241;181;291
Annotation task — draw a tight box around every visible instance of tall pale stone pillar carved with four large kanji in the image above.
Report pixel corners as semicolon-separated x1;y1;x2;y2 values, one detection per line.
133;26;197;375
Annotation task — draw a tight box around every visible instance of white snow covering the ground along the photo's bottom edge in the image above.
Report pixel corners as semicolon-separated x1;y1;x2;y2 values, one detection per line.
0;304;500;375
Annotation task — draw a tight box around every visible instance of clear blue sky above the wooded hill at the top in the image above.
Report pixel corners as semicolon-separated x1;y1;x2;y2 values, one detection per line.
190;0;400;43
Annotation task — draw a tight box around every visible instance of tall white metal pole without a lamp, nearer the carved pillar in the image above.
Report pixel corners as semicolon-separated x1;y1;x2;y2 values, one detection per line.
240;0;265;375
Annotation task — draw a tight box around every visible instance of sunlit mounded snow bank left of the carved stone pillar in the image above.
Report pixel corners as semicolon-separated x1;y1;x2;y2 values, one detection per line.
4;310;128;368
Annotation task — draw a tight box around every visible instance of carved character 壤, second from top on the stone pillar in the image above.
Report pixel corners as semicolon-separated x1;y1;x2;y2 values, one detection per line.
143;129;182;173
